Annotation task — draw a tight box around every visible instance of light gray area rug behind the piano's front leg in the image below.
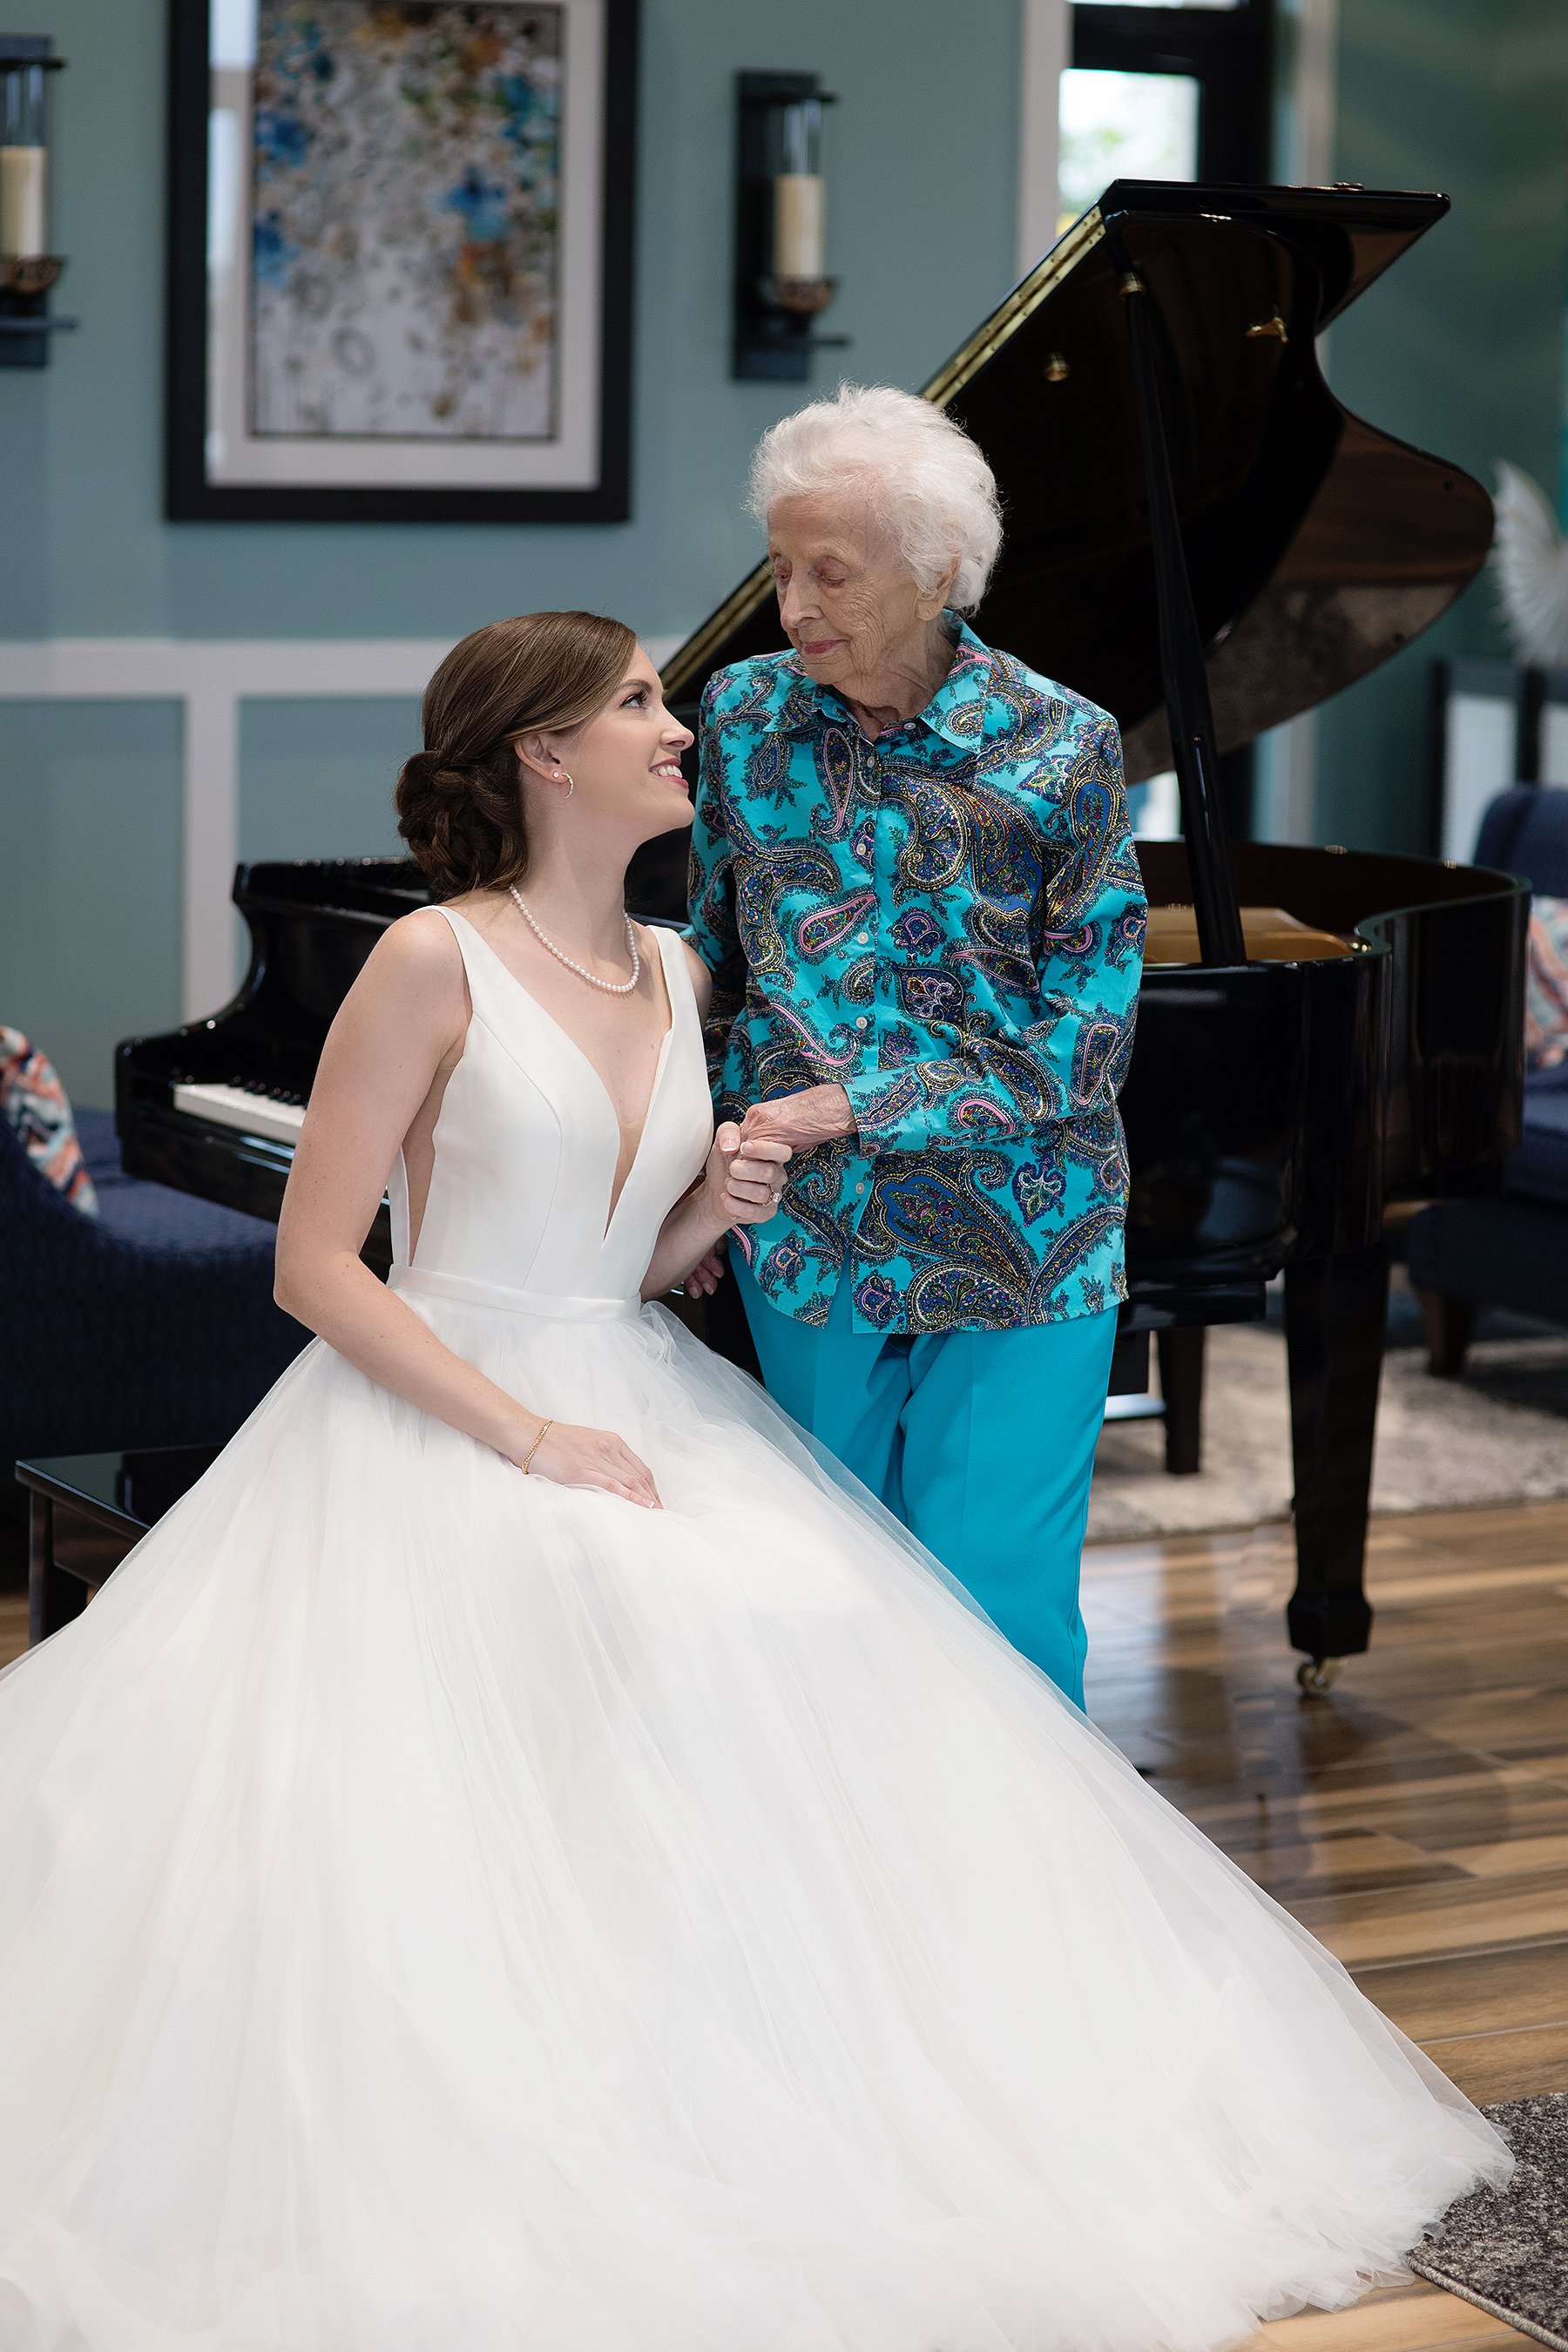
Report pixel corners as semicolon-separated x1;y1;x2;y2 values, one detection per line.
1088;1324;1568;1543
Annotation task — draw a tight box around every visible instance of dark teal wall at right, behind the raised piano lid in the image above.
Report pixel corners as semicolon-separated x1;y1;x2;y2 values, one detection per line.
1316;0;1568;849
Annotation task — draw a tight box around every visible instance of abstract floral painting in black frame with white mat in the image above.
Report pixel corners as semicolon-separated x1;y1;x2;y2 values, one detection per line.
167;0;637;522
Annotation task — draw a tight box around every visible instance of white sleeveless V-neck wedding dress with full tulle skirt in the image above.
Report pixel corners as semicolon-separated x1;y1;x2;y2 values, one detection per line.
0;917;1510;2352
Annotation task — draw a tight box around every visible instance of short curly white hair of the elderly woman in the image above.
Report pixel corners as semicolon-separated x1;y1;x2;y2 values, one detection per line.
745;383;1002;612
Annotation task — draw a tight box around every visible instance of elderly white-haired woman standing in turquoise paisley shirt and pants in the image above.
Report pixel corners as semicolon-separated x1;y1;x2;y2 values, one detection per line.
691;386;1145;1706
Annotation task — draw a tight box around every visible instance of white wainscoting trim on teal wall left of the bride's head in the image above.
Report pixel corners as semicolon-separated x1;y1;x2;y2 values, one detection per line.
0;638;679;1021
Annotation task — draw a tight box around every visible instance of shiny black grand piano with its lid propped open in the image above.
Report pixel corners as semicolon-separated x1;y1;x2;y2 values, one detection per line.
118;181;1528;1689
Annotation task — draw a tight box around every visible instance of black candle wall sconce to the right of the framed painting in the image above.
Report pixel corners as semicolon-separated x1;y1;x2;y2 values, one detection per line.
731;73;848;381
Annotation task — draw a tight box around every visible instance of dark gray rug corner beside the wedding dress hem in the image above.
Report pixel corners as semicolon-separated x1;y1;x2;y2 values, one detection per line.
1408;2091;1568;2352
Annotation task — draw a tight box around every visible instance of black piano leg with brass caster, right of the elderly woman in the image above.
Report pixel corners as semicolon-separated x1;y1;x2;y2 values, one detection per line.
1286;1242;1389;1691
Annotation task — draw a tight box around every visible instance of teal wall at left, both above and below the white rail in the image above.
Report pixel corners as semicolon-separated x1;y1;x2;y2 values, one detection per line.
0;0;1020;1103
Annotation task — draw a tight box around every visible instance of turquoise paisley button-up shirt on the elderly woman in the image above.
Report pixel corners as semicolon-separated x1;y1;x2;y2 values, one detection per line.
689;616;1145;1331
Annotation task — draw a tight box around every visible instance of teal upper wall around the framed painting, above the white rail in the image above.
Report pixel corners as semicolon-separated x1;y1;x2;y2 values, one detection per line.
0;0;1018;638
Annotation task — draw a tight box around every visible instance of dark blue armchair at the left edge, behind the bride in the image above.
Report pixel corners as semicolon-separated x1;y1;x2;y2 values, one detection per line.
0;1110;308;1482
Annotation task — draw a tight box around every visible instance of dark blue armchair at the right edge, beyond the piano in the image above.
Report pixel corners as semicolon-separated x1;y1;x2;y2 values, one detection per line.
1406;783;1568;1376
